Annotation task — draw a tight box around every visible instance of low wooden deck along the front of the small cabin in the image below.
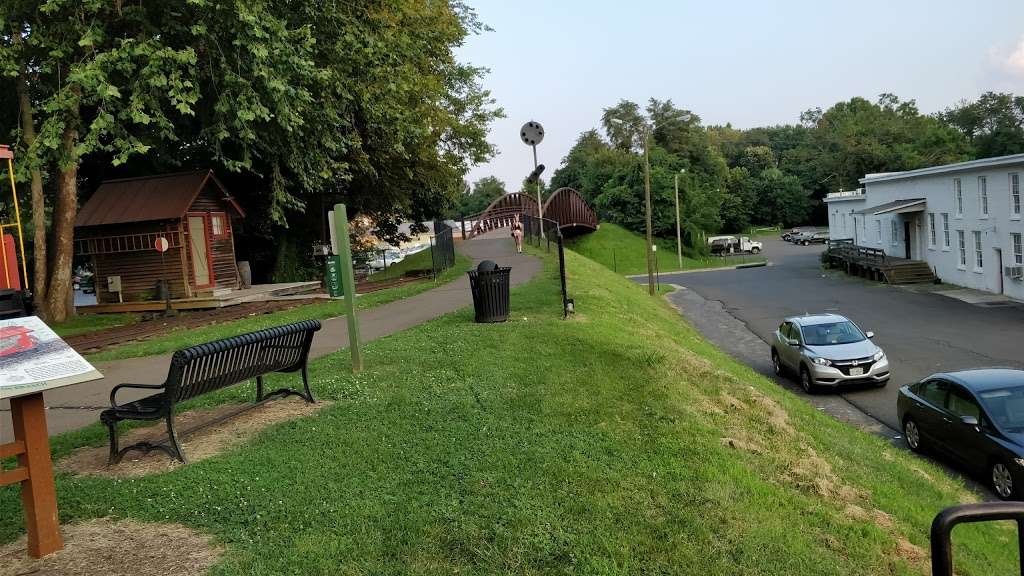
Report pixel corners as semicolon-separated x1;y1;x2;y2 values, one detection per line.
76;281;327;314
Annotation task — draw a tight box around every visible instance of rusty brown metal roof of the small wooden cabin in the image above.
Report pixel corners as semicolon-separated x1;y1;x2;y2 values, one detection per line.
75;170;245;228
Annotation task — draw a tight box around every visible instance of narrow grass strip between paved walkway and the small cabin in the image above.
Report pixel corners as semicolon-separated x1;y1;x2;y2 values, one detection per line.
83;253;472;362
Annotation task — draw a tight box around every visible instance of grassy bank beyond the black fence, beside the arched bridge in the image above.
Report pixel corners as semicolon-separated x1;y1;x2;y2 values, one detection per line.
566;223;765;276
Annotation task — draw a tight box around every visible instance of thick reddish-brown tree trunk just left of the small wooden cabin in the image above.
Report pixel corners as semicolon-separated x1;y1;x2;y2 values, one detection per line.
46;126;78;323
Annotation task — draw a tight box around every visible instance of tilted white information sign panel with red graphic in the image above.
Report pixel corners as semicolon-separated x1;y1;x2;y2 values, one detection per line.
0;316;103;400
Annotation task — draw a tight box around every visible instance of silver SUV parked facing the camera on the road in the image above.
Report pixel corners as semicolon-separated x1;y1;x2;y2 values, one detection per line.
771;314;889;394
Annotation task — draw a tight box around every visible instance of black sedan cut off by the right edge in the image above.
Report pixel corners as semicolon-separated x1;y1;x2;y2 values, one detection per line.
896;368;1024;500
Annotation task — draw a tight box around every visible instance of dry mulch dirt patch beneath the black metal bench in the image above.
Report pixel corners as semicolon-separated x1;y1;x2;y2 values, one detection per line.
56;397;331;478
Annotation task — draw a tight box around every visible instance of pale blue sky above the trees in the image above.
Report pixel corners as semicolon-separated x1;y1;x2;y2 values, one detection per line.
457;0;1024;192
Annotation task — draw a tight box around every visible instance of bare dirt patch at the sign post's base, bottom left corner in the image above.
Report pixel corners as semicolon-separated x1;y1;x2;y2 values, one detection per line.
0;519;223;576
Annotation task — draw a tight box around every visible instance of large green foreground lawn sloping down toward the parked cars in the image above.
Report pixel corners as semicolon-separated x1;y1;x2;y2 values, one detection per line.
0;243;1016;576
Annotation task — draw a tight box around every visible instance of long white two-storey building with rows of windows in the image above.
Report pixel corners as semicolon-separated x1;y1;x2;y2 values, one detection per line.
824;154;1024;299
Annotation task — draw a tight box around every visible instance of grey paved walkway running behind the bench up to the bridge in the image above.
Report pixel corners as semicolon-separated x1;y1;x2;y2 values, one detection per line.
0;231;542;434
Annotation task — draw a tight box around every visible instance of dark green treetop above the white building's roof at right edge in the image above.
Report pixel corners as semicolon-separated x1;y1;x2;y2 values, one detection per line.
938;92;1024;158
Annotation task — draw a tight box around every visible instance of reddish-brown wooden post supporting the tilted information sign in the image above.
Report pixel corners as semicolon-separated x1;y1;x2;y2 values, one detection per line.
0;393;63;558
